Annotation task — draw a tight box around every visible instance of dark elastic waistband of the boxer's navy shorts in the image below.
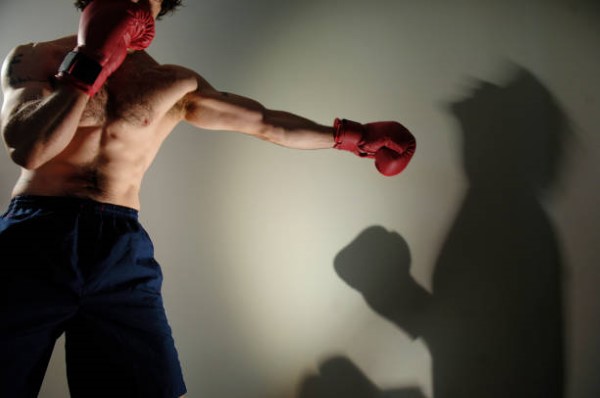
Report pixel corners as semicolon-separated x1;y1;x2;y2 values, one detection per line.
6;195;138;219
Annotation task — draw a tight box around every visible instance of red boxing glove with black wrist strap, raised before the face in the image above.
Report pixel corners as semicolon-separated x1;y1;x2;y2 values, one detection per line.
56;0;154;97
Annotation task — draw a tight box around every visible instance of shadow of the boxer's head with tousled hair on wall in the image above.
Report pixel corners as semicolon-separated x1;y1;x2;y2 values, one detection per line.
450;67;570;190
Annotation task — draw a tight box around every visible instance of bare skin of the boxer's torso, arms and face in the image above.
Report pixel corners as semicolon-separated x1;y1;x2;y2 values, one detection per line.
0;0;334;209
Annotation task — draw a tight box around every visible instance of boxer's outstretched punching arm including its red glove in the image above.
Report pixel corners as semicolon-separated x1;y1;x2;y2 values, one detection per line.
184;76;416;176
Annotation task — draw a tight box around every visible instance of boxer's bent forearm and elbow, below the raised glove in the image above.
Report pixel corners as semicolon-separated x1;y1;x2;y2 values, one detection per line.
2;85;89;169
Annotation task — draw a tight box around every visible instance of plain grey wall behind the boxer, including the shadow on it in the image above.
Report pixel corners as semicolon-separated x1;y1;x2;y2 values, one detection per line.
0;0;600;398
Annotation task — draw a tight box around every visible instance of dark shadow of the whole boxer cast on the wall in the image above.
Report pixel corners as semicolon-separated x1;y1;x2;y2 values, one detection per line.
300;69;569;398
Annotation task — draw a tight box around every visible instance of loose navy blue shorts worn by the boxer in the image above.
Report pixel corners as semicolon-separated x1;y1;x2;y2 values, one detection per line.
0;196;186;398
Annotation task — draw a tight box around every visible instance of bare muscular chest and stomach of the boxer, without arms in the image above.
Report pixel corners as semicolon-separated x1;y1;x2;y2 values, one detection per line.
7;37;197;208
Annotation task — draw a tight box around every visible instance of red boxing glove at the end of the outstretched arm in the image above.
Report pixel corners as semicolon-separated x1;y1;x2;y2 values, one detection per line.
333;119;417;176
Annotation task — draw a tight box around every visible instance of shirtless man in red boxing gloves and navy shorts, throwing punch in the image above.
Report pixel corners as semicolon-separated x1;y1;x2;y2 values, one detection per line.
0;0;415;398
